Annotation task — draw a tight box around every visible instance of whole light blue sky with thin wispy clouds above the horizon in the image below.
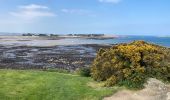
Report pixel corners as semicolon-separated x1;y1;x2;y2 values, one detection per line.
0;0;170;35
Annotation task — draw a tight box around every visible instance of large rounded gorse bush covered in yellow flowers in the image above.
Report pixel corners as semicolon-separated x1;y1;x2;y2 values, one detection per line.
91;41;170;88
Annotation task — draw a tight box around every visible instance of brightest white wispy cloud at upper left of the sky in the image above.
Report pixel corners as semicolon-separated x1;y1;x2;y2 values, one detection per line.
10;4;56;20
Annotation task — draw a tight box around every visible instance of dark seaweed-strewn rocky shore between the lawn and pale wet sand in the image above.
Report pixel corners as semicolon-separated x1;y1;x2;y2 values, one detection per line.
0;44;110;71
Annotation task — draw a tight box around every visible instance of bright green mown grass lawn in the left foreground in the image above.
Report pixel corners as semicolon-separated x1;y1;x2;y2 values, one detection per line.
0;70;118;100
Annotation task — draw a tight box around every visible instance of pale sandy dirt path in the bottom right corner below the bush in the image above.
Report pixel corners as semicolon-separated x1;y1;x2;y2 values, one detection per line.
104;78;170;100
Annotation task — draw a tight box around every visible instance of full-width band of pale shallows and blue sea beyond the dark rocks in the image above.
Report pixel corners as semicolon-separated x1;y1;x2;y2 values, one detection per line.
0;36;170;47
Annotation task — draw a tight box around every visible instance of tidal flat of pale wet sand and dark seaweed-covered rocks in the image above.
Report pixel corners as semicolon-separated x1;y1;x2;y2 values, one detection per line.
0;36;111;71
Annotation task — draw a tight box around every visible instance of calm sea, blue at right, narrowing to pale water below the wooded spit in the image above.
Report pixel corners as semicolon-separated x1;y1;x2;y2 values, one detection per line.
61;36;170;47
